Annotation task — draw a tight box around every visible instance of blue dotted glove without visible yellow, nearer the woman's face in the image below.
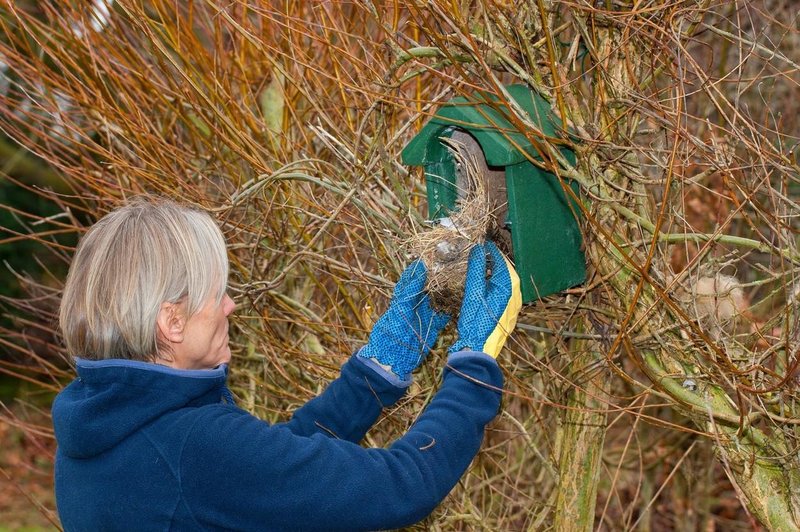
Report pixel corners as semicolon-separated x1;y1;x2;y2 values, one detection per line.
358;260;450;380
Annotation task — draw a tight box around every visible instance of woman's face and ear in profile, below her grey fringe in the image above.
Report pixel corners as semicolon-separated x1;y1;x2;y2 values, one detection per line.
170;294;236;369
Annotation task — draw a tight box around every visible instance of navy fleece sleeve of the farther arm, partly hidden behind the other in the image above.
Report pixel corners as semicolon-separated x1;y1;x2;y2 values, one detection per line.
277;355;411;443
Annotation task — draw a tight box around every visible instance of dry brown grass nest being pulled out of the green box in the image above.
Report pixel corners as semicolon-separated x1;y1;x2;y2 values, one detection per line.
403;138;510;316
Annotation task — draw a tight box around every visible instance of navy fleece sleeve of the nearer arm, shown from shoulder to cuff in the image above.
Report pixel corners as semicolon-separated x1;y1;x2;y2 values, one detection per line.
180;352;502;530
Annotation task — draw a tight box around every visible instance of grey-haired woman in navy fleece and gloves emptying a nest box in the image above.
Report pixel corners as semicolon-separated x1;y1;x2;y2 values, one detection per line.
53;199;520;531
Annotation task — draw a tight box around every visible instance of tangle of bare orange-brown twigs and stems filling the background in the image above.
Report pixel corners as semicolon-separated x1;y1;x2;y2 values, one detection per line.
0;0;800;530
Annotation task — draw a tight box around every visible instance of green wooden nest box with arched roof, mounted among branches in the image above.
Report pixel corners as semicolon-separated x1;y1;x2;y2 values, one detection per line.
401;85;586;302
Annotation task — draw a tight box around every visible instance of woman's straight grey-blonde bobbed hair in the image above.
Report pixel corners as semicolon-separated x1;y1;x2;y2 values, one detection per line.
59;197;228;362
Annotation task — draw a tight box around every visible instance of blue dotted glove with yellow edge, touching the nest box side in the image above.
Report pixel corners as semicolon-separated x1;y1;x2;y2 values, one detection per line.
448;242;522;358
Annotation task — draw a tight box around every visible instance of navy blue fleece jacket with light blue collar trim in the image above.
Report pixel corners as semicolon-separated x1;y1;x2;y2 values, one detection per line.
53;352;503;532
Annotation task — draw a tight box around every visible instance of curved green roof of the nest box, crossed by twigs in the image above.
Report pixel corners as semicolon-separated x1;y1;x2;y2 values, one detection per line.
401;85;561;166
